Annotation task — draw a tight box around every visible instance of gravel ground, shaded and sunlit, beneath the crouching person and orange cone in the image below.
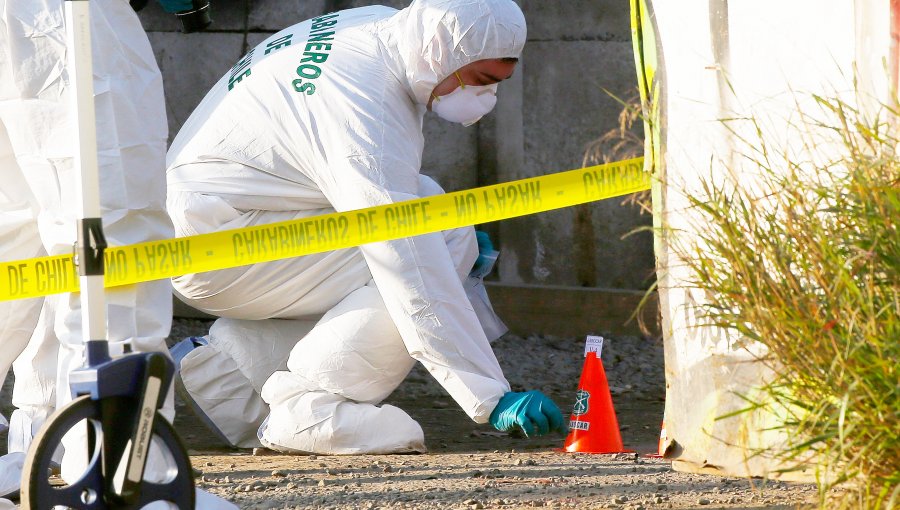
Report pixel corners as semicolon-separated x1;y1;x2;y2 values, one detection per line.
0;319;816;510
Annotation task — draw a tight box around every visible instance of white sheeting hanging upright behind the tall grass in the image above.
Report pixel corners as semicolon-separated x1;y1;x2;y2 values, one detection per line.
645;0;891;476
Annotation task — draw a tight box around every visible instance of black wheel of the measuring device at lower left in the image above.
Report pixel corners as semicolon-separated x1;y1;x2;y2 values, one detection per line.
21;395;195;510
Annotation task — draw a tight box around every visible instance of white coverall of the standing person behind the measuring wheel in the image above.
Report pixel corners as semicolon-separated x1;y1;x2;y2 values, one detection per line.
0;0;234;508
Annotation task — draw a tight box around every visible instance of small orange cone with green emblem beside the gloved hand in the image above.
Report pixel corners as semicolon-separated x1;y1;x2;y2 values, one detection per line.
563;352;629;453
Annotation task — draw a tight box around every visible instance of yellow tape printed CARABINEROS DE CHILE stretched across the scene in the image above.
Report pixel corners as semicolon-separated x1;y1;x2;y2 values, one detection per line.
0;158;650;301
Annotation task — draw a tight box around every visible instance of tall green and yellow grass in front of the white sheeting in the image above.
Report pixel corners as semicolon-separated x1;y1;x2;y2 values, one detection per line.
675;97;900;509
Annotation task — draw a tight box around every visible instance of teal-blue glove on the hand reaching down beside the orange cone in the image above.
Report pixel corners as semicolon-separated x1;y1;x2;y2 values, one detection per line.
489;390;566;436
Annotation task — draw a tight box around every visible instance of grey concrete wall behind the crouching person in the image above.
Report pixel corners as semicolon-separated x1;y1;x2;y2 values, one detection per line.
140;0;653;289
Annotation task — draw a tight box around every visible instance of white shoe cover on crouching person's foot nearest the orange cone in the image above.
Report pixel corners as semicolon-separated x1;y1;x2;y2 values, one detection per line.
259;372;427;455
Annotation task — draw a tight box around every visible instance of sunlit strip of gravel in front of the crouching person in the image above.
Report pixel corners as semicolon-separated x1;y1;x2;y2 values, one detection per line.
194;449;815;510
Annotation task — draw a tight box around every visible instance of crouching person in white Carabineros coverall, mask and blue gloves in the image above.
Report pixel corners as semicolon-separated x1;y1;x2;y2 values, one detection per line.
168;0;564;454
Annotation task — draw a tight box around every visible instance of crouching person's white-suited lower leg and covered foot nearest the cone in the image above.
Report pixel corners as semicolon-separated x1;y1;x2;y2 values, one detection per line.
260;286;425;455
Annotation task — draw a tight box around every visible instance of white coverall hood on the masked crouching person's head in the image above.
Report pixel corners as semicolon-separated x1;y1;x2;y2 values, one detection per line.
384;0;526;105
